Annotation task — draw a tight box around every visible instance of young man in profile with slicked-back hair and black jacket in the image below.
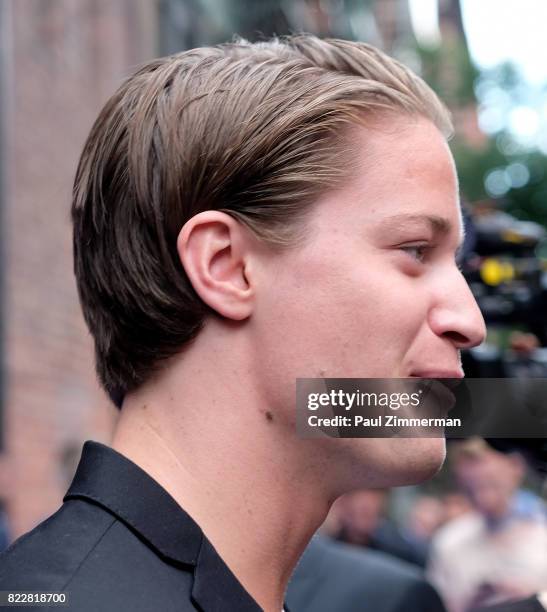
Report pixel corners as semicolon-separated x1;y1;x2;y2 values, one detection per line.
0;36;484;612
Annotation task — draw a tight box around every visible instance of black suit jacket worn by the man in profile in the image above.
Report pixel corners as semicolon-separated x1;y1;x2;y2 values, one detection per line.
0;442;268;612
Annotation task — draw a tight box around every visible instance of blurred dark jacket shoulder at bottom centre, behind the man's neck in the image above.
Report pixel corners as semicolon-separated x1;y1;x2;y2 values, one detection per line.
287;535;445;612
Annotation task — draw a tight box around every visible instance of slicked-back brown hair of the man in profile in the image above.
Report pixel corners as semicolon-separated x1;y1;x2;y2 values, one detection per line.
72;35;452;405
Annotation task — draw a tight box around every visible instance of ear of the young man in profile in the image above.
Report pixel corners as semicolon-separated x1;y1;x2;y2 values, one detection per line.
177;210;256;321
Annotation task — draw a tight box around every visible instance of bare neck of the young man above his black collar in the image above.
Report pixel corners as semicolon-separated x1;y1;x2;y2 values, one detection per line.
112;334;332;612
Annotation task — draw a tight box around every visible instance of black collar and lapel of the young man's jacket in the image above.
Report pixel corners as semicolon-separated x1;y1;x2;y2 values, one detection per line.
63;441;261;612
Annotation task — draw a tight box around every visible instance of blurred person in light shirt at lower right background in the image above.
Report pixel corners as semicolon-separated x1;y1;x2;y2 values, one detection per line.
428;438;547;612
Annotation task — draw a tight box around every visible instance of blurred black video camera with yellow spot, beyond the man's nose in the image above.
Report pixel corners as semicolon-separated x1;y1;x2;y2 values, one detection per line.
460;202;547;476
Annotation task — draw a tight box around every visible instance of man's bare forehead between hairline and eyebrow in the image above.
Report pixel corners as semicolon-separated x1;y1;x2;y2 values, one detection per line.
312;116;460;227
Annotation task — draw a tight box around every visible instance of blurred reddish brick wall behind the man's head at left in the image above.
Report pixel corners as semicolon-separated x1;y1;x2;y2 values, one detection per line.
0;0;157;537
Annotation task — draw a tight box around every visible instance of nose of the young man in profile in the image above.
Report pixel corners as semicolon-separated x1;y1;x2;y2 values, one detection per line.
429;269;486;349
